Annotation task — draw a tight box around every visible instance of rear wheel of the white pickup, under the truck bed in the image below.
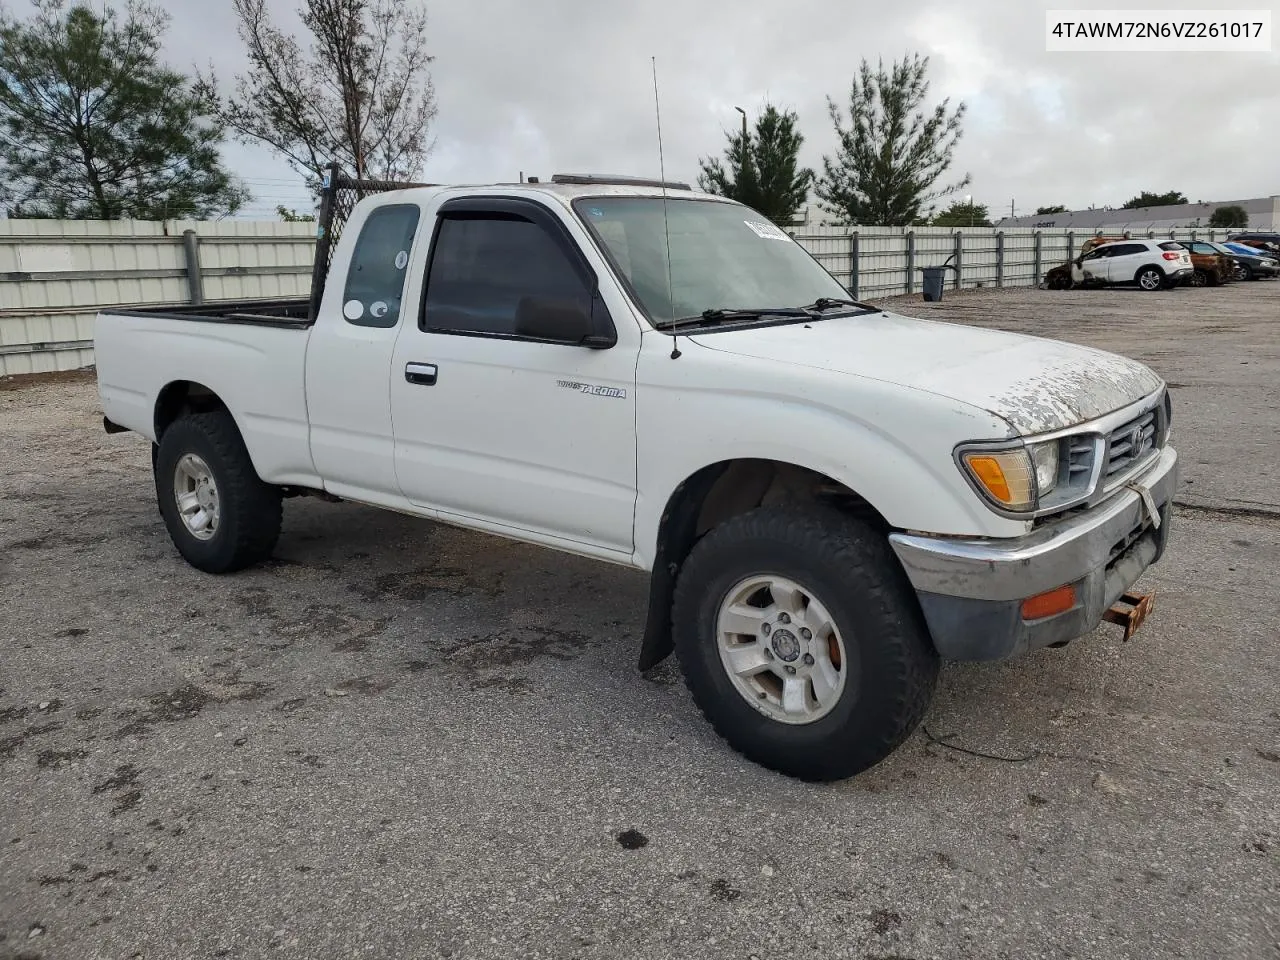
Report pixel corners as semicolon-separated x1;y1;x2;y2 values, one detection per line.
155;411;280;573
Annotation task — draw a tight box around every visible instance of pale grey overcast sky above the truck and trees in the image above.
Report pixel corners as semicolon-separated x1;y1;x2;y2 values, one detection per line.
10;0;1280;216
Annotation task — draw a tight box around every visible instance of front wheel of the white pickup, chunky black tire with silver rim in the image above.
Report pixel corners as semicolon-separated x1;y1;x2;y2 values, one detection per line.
672;507;938;781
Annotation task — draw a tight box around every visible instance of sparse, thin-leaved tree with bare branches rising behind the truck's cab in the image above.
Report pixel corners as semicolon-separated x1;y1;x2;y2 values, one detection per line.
202;0;436;184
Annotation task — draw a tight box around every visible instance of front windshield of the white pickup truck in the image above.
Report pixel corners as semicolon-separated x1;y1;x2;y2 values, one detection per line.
573;197;849;323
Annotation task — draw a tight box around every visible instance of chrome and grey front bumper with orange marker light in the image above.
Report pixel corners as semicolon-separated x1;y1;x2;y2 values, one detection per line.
890;447;1178;660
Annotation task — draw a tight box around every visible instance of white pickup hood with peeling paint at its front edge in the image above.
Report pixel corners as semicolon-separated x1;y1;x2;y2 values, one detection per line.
691;312;1164;435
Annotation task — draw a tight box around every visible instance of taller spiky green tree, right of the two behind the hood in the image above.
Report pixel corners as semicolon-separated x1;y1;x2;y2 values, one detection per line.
817;55;969;225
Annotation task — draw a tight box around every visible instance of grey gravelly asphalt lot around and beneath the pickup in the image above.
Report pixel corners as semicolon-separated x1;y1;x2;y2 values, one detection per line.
0;283;1280;960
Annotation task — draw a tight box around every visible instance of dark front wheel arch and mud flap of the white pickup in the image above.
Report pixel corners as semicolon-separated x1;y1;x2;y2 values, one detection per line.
639;457;891;671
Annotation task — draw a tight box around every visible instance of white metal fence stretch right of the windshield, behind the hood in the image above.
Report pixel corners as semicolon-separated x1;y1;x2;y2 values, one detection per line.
792;227;1234;300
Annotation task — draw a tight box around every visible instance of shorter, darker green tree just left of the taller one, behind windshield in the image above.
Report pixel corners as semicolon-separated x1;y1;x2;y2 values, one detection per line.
698;104;814;227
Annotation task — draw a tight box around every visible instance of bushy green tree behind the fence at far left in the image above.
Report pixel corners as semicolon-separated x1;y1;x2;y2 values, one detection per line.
0;0;248;220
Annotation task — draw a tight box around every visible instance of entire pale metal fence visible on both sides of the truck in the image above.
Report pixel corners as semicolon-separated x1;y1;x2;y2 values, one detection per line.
0;217;1249;375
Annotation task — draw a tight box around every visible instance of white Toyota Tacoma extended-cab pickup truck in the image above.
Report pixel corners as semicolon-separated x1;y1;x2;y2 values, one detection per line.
95;177;1178;780
